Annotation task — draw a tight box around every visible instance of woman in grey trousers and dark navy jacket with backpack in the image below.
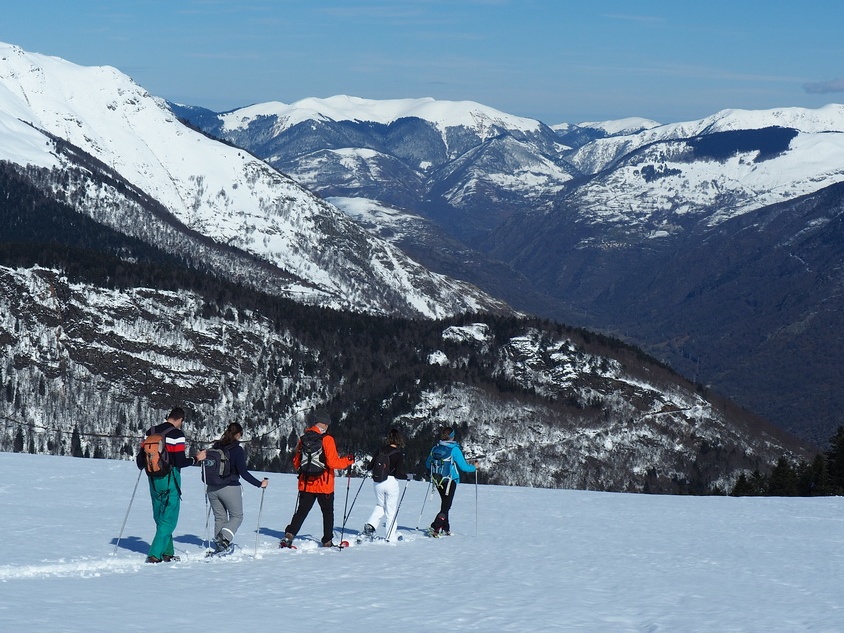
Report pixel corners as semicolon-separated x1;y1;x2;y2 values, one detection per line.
202;422;269;553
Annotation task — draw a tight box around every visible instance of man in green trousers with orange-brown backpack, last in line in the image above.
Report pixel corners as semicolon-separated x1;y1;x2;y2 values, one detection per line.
136;407;205;563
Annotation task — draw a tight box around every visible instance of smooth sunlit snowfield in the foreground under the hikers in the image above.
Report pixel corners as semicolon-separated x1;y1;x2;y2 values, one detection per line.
0;452;844;632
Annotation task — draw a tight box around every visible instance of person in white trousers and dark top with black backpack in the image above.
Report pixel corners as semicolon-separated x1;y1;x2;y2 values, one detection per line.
363;429;407;542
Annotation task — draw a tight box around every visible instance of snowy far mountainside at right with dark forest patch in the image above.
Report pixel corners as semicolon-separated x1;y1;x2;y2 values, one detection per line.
566;105;844;239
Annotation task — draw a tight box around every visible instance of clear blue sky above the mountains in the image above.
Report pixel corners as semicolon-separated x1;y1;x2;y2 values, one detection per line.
0;0;844;124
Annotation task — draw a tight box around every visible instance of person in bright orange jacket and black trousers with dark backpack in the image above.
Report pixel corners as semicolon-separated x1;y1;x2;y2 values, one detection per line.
279;410;355;547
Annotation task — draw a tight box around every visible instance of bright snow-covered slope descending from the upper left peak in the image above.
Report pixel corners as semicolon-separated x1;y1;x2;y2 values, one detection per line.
0;44;504;317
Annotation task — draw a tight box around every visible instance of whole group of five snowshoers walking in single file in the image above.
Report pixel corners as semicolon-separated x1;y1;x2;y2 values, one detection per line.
136;407;477;563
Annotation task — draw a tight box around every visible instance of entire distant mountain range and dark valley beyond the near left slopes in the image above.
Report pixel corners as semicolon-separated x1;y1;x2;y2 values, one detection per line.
175;97;844;442
